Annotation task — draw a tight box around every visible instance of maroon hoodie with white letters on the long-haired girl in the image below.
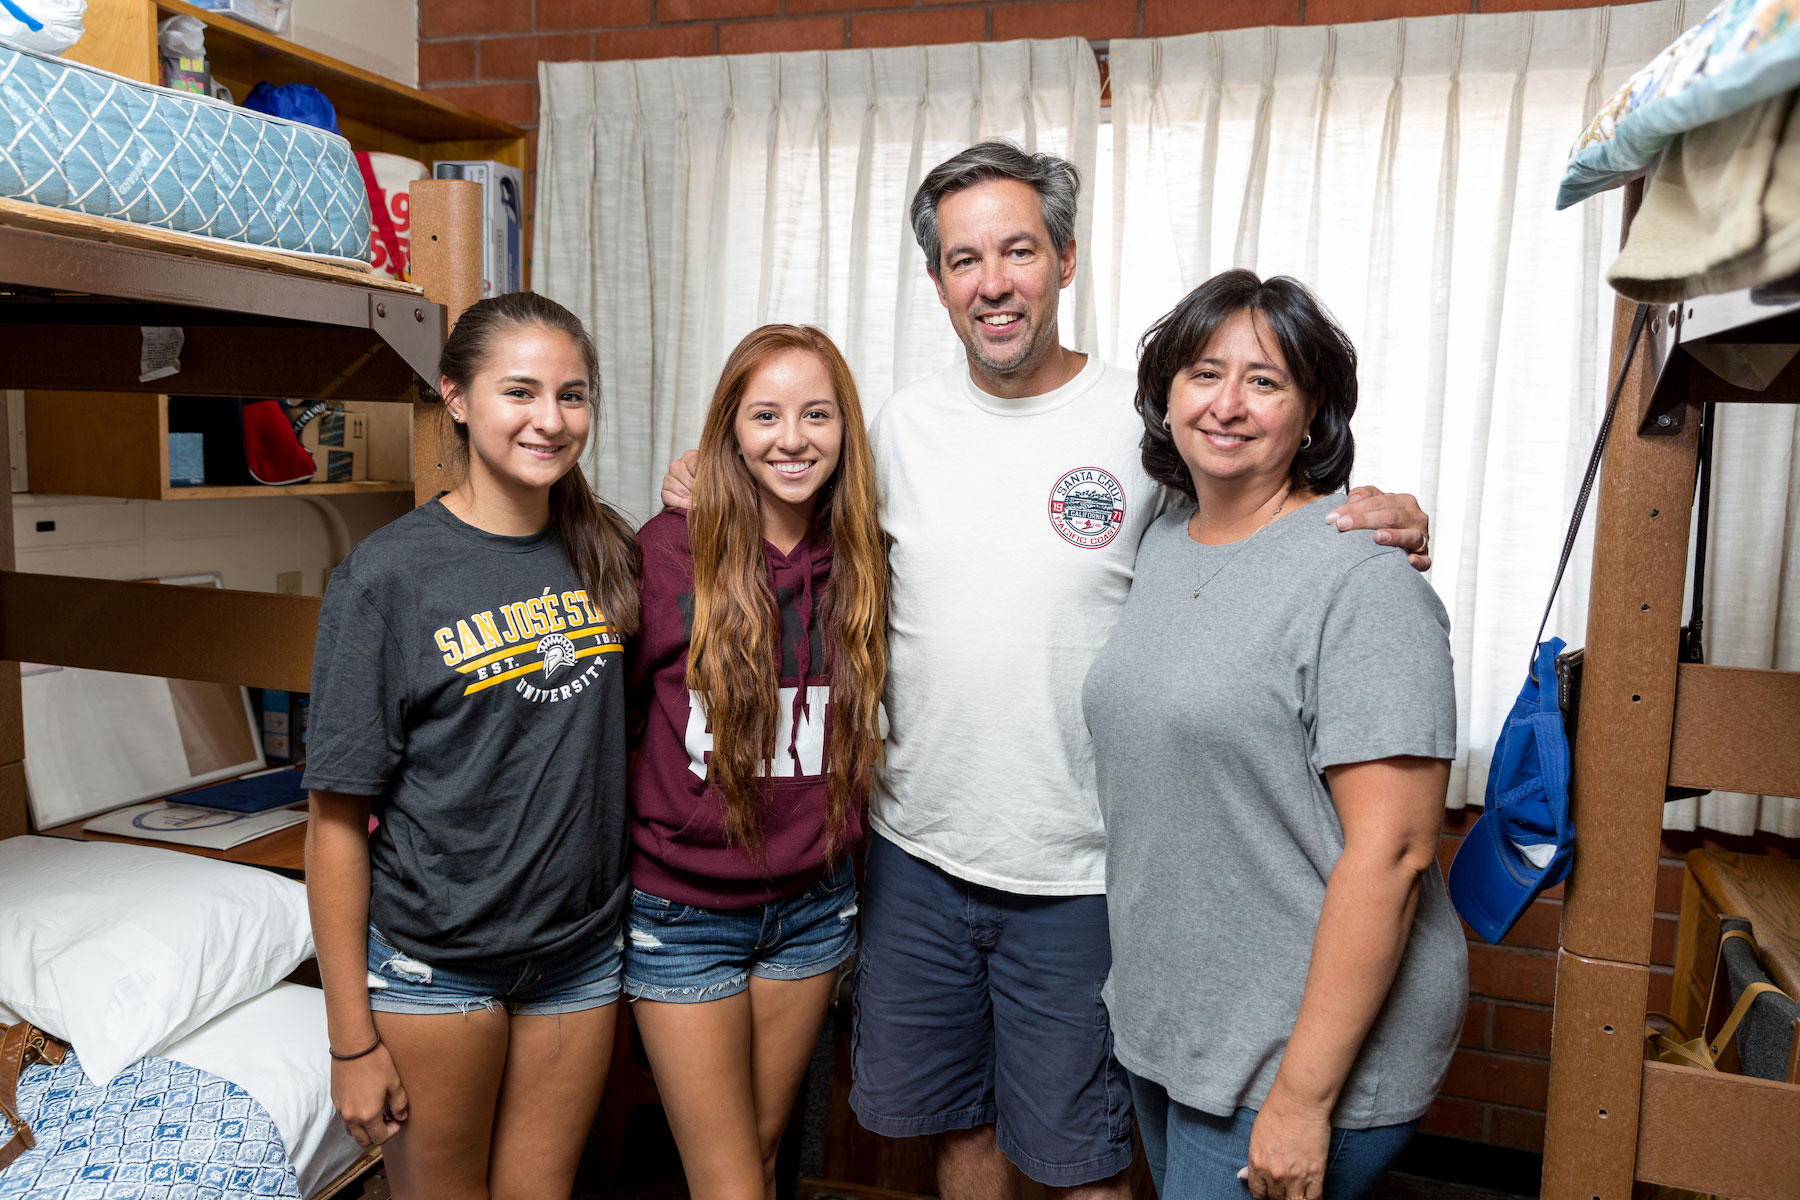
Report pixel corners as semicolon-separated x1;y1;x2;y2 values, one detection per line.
625;511;862;909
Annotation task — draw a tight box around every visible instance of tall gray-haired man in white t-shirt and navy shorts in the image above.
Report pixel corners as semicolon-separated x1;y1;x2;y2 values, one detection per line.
664;142;1429;1200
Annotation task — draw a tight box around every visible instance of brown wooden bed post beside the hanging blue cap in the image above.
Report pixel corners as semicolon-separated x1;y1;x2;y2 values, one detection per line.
1543;184;1699;1200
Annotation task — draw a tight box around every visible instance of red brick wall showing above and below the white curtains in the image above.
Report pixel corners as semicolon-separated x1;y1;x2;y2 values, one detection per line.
419;0;1800;1150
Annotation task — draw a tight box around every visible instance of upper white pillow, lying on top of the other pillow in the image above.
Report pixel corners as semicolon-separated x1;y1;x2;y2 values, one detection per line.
0;837;313;1087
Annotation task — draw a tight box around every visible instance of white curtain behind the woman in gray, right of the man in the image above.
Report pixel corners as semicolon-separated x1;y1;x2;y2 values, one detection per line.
1098;0;1800;835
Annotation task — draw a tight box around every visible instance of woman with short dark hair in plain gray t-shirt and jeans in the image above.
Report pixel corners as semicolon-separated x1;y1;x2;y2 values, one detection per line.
1082;270;1467;1200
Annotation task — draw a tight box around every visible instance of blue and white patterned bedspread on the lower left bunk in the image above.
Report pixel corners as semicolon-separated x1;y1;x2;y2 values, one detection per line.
0;1051;301;1200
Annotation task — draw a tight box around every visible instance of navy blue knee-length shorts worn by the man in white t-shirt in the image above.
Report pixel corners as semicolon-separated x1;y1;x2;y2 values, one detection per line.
850;835;1130;1200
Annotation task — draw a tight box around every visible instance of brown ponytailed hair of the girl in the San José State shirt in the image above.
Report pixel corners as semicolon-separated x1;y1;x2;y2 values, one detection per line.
437;291;639;637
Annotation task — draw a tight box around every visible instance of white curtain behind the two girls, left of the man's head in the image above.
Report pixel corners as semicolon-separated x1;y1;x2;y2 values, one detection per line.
533;38;1100;520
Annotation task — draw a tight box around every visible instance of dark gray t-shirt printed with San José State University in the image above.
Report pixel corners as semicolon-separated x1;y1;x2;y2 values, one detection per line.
306;500;628;964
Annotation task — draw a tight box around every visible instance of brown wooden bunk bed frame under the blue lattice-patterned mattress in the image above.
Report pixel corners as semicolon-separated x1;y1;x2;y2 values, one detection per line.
0;180;482;837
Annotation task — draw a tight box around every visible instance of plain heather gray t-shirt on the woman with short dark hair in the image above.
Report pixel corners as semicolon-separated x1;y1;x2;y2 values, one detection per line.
1082;497;1469;1128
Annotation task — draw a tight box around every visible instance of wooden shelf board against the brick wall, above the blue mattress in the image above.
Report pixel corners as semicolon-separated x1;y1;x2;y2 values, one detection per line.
157;0;524;142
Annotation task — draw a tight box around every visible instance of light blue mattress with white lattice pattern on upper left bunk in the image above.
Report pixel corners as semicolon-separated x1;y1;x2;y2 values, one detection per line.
0;45;369;263
